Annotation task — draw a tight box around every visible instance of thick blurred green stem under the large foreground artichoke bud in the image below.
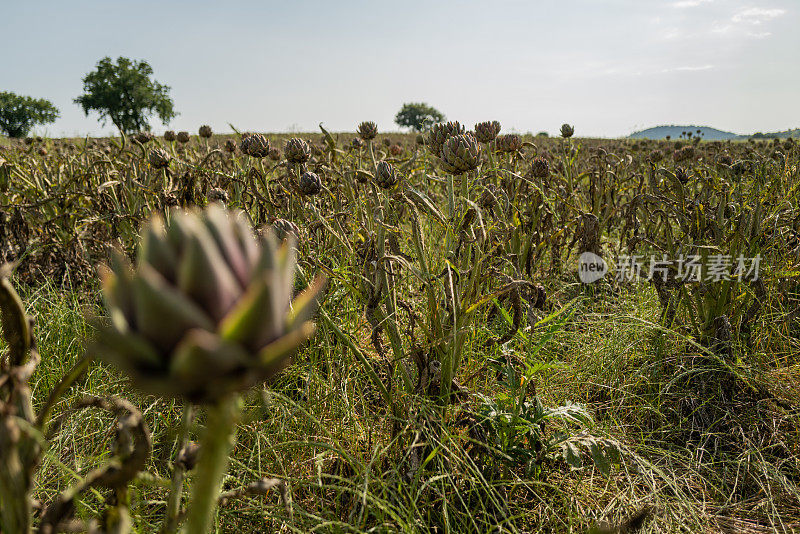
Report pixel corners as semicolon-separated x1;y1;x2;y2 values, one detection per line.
184;395;241;534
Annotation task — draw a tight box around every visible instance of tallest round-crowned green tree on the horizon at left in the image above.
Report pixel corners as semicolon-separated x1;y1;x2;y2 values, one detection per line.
75;57;177;133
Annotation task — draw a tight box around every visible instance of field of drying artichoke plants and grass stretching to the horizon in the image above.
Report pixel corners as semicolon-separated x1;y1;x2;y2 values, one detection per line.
0;123;800;533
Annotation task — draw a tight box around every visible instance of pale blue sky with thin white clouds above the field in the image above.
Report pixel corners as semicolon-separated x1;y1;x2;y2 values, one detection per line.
0;0;800;137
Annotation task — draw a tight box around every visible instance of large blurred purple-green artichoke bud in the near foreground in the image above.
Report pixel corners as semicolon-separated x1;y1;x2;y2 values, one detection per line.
94;205;324;403
